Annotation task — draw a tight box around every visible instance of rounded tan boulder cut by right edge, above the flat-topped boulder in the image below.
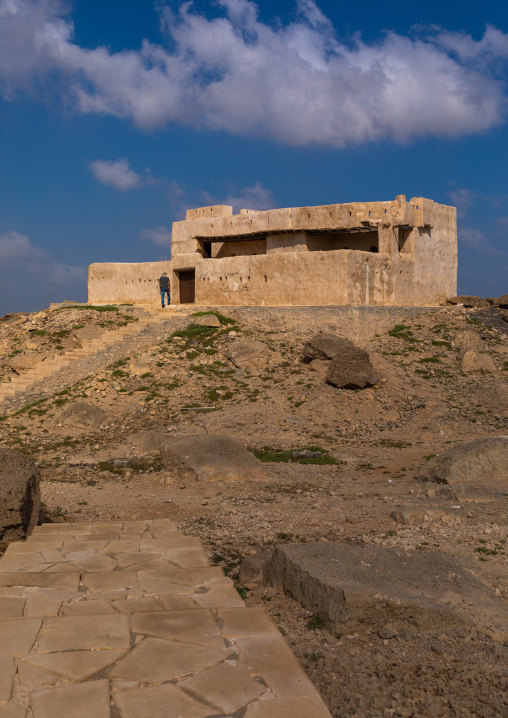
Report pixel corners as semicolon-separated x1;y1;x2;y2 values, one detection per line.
416;436;508;492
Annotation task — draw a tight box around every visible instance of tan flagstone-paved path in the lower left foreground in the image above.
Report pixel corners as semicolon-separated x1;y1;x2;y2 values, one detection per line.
0;520;330;718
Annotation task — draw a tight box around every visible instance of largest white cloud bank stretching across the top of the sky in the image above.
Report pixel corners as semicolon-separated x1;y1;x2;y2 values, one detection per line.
0;0;508;147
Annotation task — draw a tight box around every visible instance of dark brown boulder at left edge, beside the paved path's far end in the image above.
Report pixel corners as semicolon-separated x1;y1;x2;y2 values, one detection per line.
0;449;41;551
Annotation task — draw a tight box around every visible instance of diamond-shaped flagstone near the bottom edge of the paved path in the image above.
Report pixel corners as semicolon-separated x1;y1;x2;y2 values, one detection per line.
179;663;266;713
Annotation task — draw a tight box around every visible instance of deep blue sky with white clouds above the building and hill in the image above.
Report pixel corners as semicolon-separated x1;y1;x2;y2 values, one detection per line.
0;0;508;314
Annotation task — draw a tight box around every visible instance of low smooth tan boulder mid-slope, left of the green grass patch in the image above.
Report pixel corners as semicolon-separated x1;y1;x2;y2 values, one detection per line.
161;434;268;482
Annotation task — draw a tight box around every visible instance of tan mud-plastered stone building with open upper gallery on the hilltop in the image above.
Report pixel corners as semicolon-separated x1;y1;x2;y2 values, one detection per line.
88;195;457;306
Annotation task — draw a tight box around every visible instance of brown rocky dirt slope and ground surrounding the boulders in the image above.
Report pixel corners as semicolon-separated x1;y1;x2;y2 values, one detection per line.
0;300;508;718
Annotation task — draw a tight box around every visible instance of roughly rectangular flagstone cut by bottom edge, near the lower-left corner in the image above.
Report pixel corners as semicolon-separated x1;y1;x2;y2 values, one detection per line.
30;680;111;718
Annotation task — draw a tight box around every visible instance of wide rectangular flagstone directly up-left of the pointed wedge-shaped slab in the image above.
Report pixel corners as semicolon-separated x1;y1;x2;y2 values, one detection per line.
38;613;130;653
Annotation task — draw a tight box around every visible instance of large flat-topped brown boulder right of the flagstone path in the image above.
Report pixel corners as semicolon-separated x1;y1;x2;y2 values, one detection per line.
264;541;508;640
